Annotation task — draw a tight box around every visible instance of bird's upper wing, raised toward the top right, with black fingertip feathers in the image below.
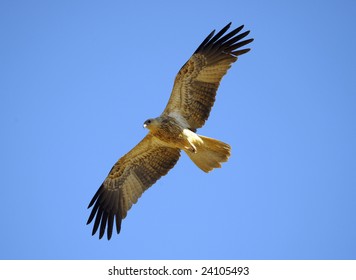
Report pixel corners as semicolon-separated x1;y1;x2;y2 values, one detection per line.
163;22;253;130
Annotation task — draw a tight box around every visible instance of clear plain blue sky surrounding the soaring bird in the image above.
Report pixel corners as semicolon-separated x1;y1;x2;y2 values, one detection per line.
0;0;356;259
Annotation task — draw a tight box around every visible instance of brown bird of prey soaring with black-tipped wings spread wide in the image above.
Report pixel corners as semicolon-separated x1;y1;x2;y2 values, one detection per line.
87;22;253;240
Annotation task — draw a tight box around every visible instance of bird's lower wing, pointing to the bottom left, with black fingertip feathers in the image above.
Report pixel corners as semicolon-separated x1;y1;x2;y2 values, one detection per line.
87;133;180;239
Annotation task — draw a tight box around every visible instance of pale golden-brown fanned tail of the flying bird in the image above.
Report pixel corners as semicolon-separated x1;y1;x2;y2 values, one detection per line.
185;135;230;172
